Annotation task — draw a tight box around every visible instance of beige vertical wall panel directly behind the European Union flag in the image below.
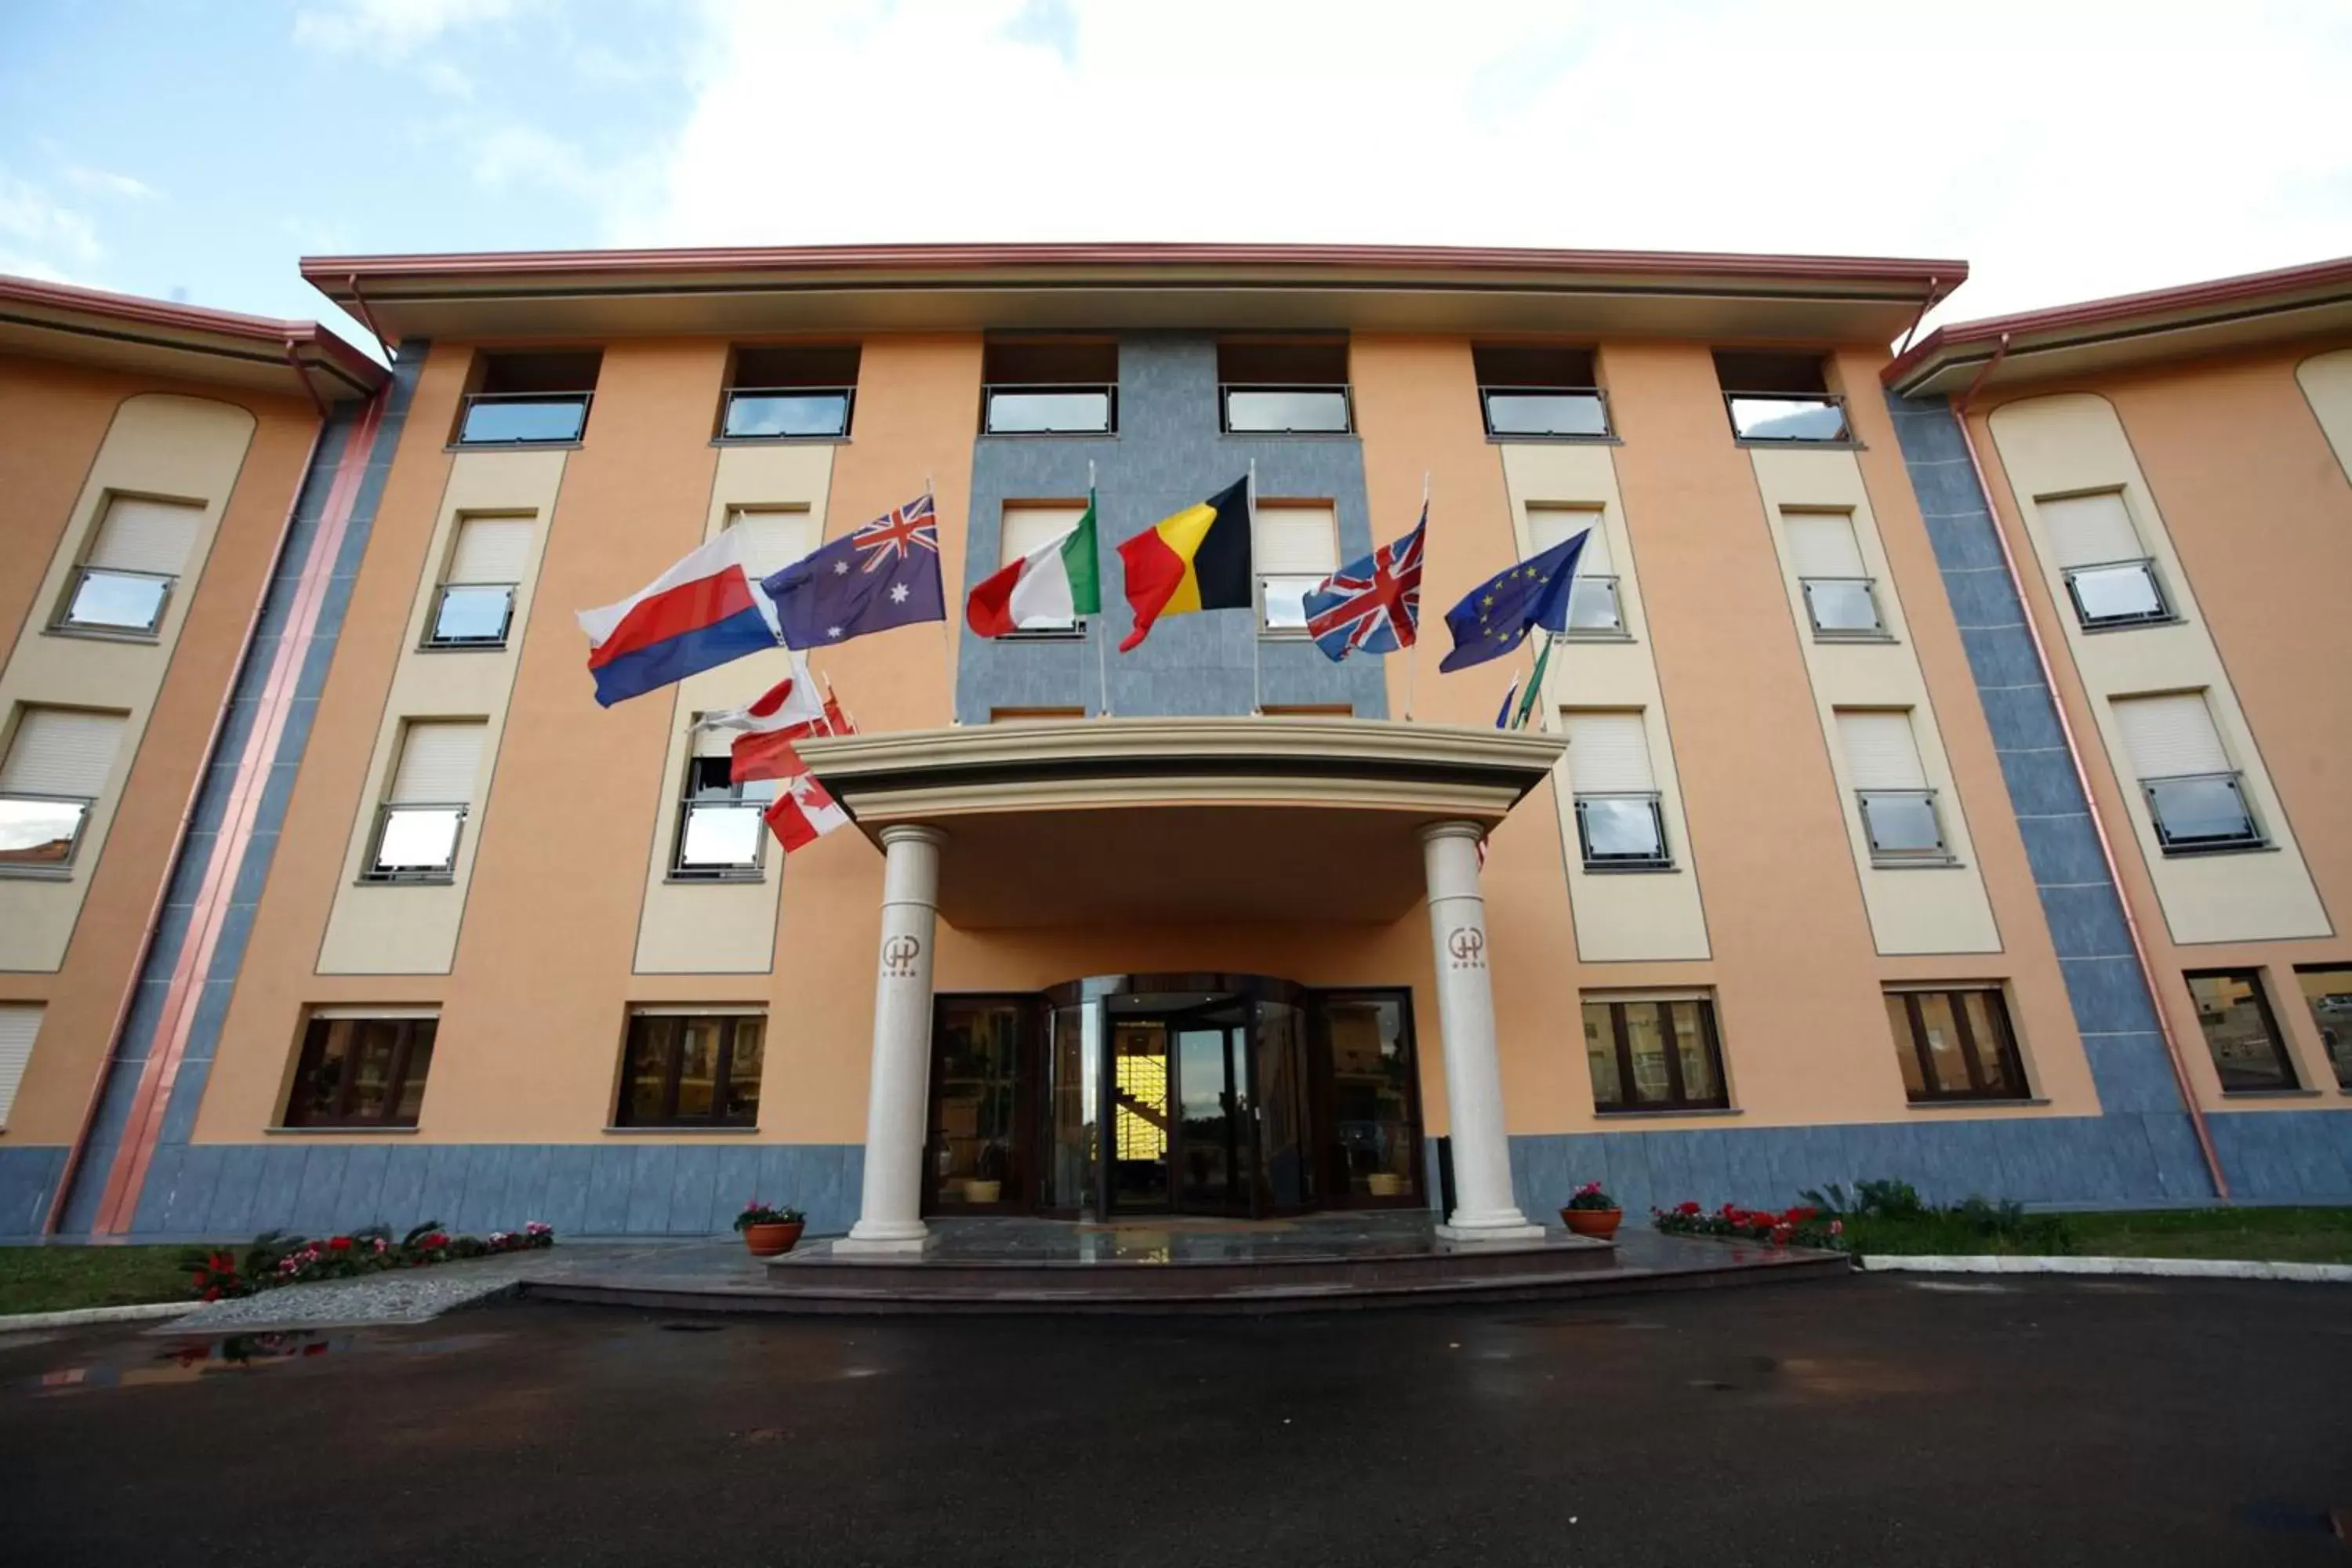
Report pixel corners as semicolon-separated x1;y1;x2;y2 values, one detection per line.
1498;442;1708;964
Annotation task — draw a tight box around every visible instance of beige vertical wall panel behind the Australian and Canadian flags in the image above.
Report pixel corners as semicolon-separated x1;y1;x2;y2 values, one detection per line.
635;445;833;973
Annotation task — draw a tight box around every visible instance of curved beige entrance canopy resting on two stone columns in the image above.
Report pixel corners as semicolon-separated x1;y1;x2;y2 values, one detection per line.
800;717;1564;928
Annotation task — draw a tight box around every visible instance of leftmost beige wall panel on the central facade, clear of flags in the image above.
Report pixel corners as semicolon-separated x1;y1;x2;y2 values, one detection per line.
318;452;569;975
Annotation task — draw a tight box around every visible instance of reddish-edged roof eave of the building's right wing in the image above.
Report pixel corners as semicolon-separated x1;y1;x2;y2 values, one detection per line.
1882;256;2352;397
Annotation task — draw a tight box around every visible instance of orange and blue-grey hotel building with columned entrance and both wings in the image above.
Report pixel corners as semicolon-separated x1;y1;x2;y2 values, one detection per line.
0;245;2352;1250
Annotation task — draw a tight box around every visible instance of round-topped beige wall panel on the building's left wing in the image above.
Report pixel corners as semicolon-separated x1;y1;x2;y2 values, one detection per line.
0;393;254;971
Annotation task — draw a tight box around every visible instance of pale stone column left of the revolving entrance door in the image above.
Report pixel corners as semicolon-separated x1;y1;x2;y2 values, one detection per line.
833;822;948;1253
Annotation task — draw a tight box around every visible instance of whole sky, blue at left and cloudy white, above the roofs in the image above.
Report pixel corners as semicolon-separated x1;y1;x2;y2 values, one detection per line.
0;0;2352;354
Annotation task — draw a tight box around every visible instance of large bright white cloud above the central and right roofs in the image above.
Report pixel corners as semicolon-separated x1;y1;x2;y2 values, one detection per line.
621;0;2352;315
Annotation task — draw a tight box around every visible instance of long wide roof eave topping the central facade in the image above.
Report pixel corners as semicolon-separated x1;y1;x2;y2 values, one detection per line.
303;245;1969;343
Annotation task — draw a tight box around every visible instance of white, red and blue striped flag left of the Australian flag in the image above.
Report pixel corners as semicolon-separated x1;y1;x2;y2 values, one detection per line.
579;529;779;708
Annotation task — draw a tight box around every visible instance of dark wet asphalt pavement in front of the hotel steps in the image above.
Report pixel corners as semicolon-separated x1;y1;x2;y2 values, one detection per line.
0;1276;2352;1568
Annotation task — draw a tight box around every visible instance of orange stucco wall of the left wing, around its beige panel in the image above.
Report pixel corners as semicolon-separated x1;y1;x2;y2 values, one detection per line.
0;355;320;1145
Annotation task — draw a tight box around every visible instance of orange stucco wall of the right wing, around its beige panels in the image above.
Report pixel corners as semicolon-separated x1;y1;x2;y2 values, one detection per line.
1969;343;2352;1109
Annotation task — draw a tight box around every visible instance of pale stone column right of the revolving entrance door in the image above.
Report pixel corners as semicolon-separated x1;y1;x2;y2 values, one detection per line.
1411;822;1543;1241
